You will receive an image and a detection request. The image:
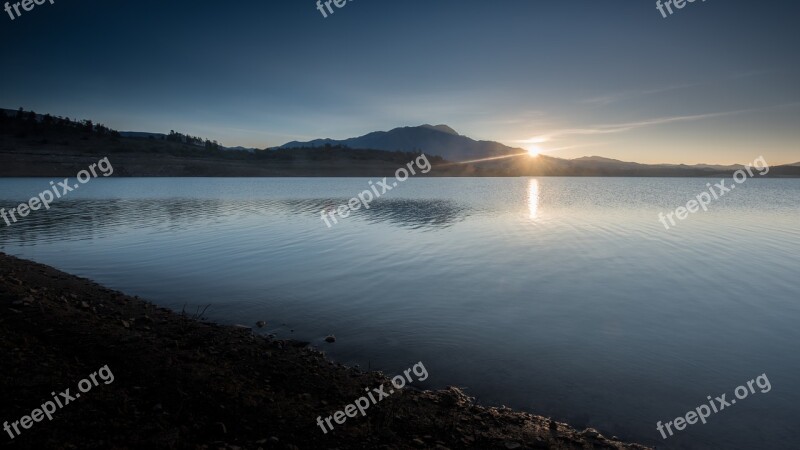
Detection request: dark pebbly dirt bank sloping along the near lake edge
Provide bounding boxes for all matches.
[0,252,648,450]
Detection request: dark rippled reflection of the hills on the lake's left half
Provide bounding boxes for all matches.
[0,198,468,245]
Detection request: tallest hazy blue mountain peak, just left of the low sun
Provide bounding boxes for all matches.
[278,124,527,162]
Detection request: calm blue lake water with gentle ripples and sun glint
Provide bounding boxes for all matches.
[0,178,800,449]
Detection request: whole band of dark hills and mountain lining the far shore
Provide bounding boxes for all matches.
[0,110,800,178]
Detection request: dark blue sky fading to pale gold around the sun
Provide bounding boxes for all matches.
[0,0,800,165]
